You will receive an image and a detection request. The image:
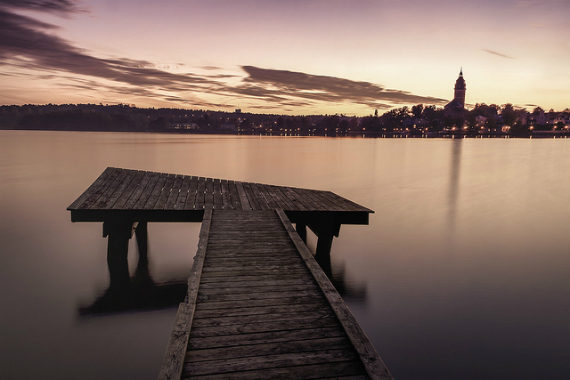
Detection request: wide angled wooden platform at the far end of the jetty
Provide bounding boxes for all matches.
[67,168,372,224]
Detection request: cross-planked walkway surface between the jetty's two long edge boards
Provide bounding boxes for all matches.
[175,211,374,378]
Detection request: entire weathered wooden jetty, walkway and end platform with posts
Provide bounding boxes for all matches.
[68,168,392,379]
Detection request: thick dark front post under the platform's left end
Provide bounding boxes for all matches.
[103,220,136,290]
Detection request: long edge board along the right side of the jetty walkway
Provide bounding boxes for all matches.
[276,210,392,379]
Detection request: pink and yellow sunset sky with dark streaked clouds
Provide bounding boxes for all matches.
[0,0,570,115]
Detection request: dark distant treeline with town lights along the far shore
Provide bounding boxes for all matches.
[0,104,570,136]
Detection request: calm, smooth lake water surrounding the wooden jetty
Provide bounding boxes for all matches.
[0,131,570,379]
